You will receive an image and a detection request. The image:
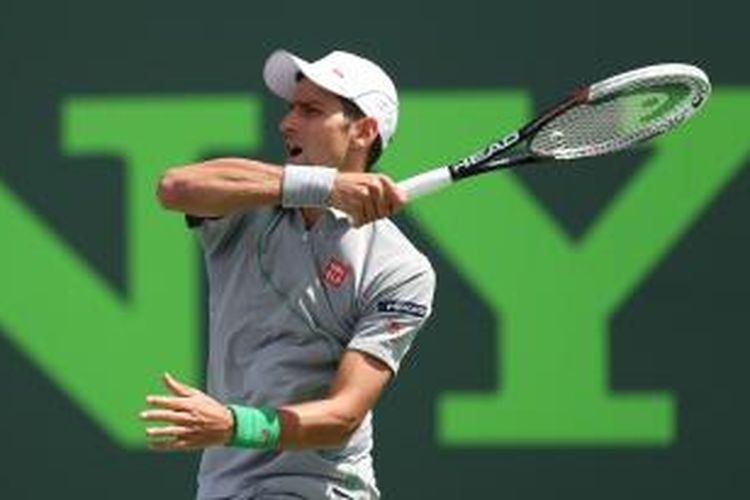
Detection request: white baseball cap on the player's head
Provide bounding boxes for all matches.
[263,50,398,148]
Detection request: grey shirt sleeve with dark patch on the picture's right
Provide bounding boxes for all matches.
[347,261,435,374]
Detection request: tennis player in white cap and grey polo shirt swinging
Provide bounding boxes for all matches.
[141,47,435,499]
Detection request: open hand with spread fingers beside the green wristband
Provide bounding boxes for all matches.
[140,373,234,451]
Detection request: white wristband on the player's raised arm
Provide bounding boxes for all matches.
[281,165,337,208]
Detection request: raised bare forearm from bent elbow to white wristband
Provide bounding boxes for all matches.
[157,158,283,217]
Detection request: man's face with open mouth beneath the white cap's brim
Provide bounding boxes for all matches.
[279,78,360,168]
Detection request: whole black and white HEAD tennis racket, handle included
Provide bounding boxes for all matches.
[398,63,711,199]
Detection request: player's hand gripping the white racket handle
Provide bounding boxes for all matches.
[329,172,407,227]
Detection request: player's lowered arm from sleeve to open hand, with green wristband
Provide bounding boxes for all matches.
[141,350,391,450]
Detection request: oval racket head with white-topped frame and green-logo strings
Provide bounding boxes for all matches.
[528,63,711,160]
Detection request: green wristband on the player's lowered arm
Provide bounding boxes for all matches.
[227,405,281,450]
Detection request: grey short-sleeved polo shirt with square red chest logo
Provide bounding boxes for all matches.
[191,207,435,499]
